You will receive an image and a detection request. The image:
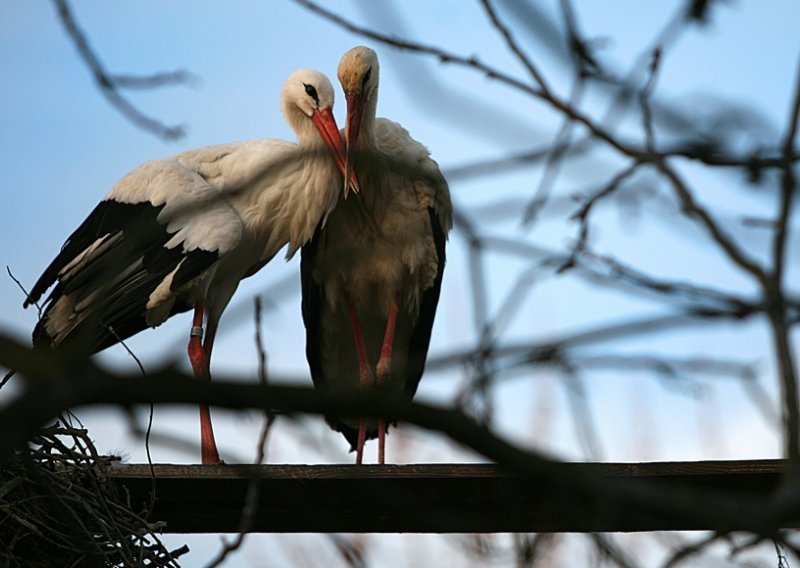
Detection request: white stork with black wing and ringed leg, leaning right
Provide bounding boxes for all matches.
[24,69,357,464]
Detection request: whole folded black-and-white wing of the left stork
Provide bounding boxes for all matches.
[26,156,242,353]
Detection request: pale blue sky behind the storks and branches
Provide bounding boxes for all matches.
[0,0,800,566]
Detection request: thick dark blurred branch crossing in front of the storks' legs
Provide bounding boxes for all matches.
[0,338,800,537]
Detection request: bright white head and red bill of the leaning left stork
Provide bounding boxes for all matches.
[281,69,358,191]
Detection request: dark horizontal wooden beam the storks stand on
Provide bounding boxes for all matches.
[110,460,784,533]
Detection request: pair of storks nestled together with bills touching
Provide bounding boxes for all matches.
[25,46,452,463]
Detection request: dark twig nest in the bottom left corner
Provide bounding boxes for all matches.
[0,420,188,568]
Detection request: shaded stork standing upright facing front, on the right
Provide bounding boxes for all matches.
[300,46,452,463]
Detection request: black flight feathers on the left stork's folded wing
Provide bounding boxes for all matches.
[26,200,219,352]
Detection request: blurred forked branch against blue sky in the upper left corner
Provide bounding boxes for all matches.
[53,0,193,140]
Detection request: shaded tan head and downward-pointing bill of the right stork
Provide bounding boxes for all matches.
[338,45,379,197]
